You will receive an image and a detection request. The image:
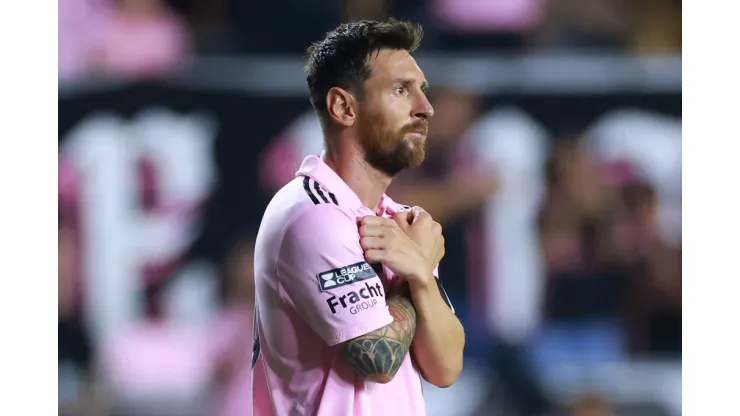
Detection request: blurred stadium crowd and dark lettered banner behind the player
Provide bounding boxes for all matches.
[59,0,682,416]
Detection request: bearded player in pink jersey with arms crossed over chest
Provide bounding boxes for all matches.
[253,20,465,416]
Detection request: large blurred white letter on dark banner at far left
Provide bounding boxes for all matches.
[60,109,216,339]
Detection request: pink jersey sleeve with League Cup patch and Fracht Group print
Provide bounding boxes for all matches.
[278,204,393,345]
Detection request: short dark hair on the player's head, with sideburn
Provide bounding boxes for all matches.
[305,19,424,128]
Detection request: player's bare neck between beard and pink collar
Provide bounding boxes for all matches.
[322,135,393,212]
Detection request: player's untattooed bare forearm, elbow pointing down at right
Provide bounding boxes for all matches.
[411,282,465,387]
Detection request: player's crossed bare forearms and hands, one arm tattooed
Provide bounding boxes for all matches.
[347,209,464,387]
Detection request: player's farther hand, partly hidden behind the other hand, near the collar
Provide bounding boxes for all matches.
[393,207,445,267]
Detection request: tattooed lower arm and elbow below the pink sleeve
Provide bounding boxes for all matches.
[340,295,416,378]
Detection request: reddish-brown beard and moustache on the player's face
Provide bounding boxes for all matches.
[358,109,428,177]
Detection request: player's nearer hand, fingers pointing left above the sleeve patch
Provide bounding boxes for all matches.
[359,215,436,284]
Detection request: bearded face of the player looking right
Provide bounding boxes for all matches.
[357,50,434,176]
